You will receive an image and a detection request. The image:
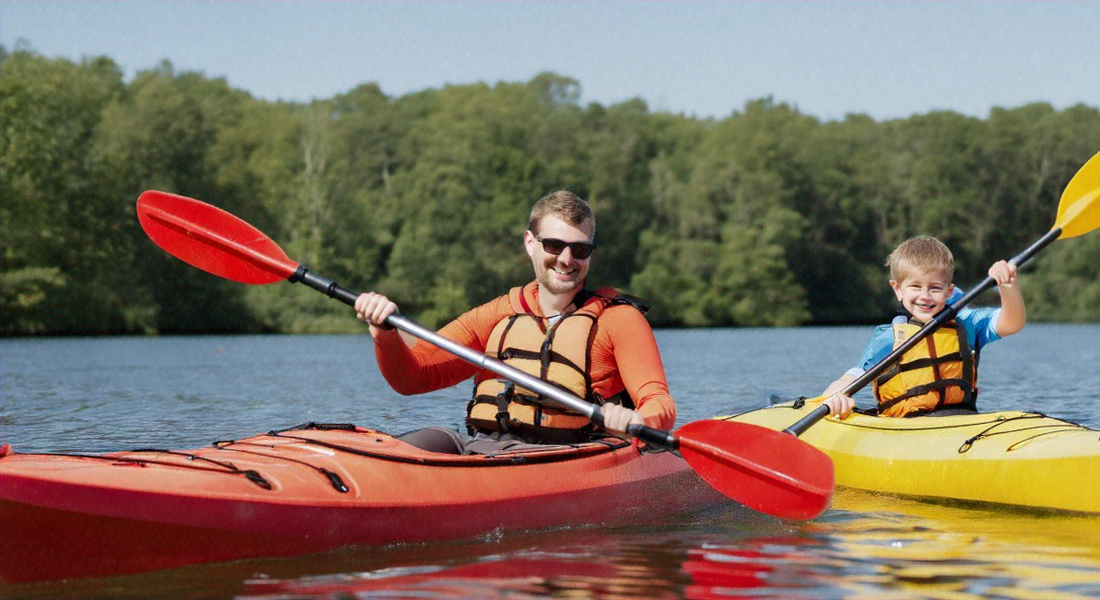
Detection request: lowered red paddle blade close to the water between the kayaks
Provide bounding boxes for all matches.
[675,419,834,520]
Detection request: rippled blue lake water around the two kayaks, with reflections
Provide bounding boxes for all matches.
[0,325,1100,599]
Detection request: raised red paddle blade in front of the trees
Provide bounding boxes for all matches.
[138,190,298,284]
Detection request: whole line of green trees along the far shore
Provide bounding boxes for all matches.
[0,48,1100,336]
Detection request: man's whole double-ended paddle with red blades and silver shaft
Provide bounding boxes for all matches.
[138,190,834,520]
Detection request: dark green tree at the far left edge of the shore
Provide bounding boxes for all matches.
[0,51,134,335]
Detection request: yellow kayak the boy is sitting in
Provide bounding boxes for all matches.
[716,401,1100,513]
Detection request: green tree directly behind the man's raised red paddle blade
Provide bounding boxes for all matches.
[95,63,256,332]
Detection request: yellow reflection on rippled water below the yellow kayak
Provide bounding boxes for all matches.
[812,491,1100,599]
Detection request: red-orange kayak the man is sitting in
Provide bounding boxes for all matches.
[0,424,724,582]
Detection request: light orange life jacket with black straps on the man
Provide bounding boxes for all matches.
[466,287,644,444]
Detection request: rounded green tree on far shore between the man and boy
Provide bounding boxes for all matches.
[631,100,815,326]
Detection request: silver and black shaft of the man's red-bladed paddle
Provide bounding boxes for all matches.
[288,265,679,450]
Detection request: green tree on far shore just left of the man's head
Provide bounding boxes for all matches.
[378,84,558,324]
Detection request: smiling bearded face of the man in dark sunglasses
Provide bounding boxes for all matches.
[524,215,593,294]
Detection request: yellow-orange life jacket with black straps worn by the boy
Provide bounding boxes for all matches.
[873,320,978,416]
